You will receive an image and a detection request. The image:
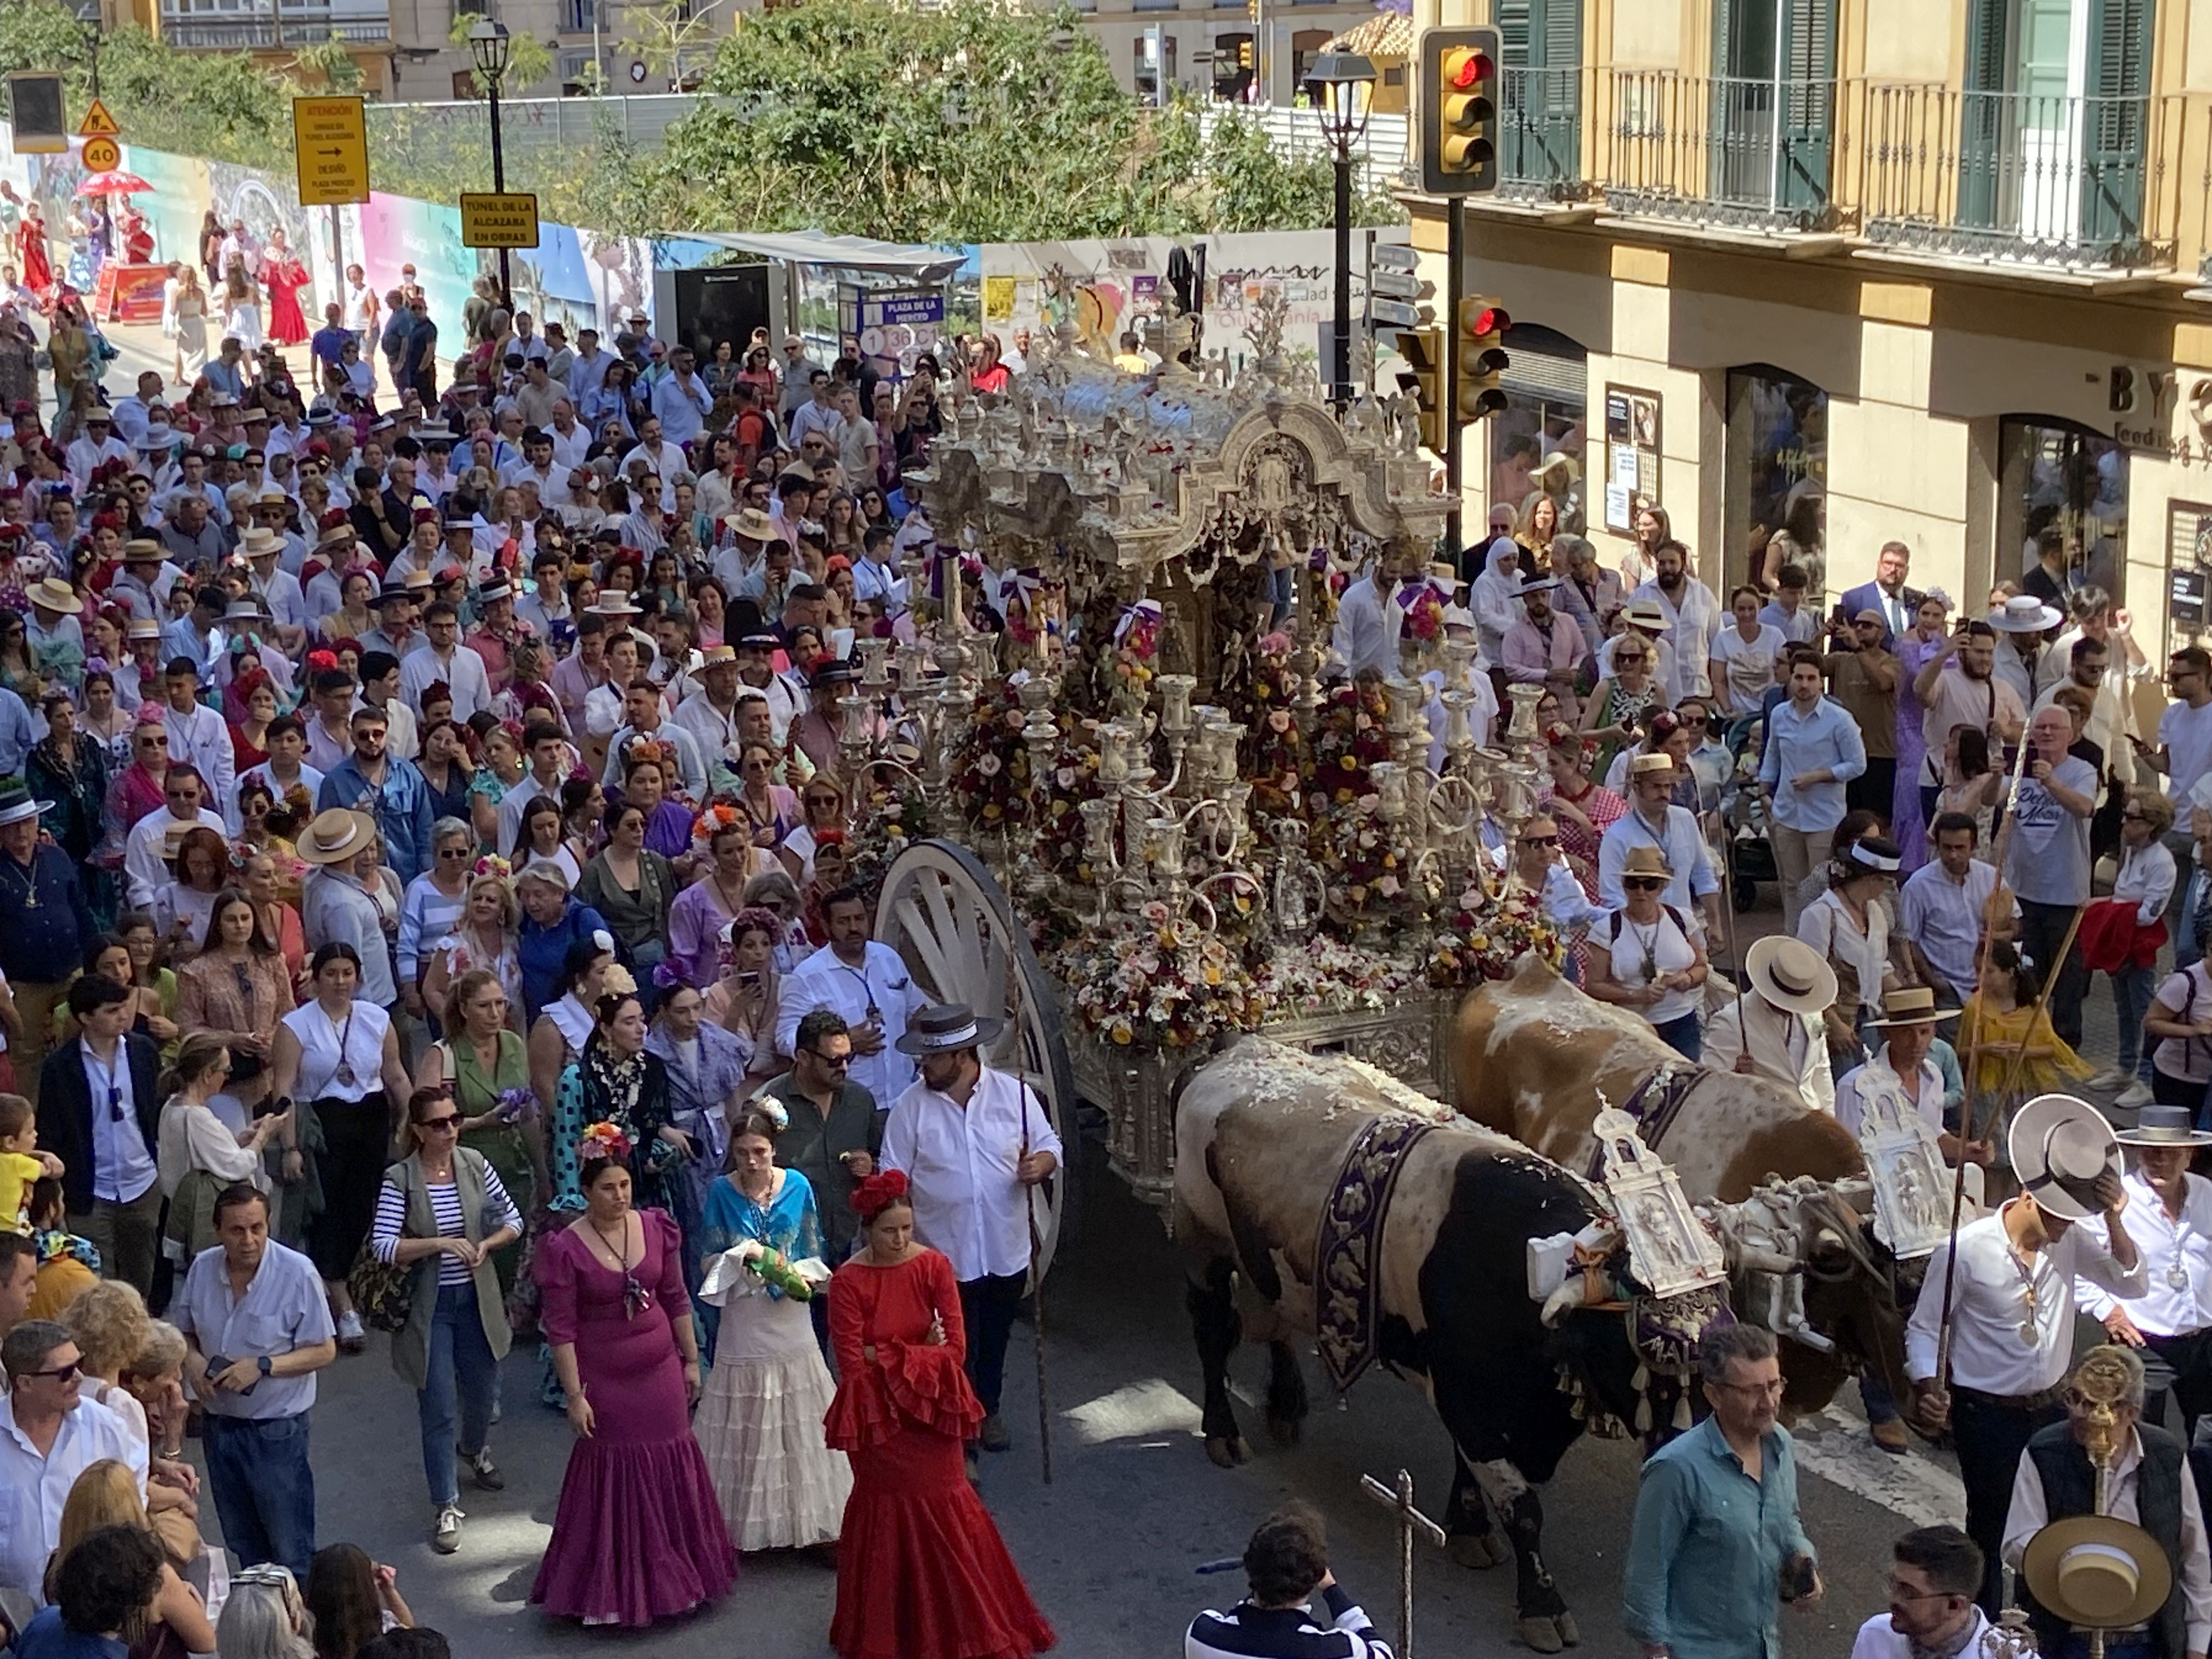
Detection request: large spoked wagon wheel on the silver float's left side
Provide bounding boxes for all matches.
[876,840,1082,1285]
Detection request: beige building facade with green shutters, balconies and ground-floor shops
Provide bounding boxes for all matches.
[1409,0,2212,652]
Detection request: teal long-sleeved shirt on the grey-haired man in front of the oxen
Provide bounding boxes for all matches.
[1621,1418,1814,1659]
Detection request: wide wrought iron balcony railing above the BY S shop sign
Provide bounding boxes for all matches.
[1849,84,2201,270]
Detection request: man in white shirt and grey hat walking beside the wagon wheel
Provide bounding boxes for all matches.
[878,1002,1062,1458]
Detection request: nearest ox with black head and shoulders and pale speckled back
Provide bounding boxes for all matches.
[1175,1037,1697,1652]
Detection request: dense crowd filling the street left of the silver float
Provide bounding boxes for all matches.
[0,253,1097,1659]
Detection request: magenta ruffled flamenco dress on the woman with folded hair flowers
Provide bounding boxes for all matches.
[531,1210,737,1626]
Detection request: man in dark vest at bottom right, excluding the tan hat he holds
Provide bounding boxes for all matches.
[2004,1345,2212,1659]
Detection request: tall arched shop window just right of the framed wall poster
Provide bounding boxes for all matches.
[1716,363,1822,606]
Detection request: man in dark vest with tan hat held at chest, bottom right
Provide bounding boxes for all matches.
[2004,1345,2212,1659]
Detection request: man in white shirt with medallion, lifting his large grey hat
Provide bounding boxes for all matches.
[1905,1095,2148,1612]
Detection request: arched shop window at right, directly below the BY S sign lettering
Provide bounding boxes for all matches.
[1973,416,2123,619]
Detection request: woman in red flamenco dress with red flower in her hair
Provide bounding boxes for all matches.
[823,1170,1053,1659]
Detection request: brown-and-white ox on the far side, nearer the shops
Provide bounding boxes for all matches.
[1451,958,1920,1413]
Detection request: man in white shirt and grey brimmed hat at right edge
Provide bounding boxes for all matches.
[2081,1106,2212,1442]
